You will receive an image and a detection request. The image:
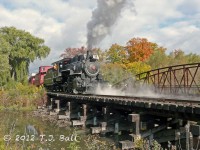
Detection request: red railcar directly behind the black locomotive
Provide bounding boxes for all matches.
[33,66,52,86]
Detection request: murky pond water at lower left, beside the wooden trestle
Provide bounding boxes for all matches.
[0,111,117,150]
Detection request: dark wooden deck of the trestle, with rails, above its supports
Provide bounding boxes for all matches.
[47,92,200,115]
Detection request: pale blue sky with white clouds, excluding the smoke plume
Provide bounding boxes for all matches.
[0,0,200,73]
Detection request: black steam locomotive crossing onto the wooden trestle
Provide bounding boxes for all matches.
[44,51,103,94]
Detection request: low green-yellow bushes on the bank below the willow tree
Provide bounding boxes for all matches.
[0,81,46,110]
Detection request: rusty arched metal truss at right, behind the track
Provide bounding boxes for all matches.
[136,63,200,95]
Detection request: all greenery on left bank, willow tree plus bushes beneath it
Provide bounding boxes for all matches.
[0,27,50,109]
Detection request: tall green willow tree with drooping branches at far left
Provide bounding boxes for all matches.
[0,27,50,81]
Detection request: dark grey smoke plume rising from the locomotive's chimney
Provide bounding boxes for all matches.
[87,0,134,49]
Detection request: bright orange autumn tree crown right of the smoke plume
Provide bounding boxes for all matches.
[126,38,153,62]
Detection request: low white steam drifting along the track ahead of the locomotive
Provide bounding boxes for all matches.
[94,80,199,100]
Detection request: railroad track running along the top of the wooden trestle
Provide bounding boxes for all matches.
[47,92,200,107]
